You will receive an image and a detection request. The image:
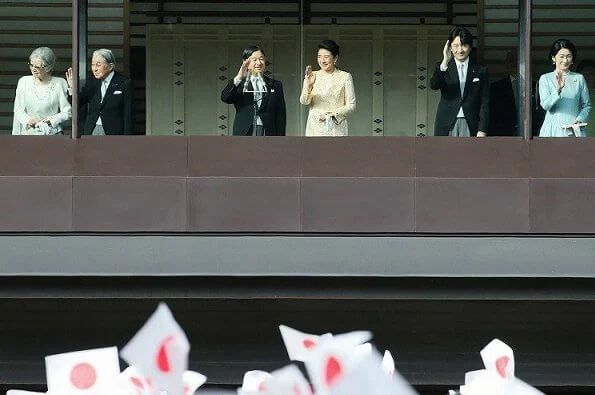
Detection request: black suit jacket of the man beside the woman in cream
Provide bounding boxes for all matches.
[221,75,287,136]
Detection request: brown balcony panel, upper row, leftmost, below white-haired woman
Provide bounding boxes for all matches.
[0,136,74,176]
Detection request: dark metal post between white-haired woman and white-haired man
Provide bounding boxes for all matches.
[71,0,88,139]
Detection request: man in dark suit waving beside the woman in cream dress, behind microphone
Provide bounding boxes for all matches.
[221,46,287,136]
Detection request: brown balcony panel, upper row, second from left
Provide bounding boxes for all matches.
[75,136,187,177]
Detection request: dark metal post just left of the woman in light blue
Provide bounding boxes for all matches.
[517,0,533,140]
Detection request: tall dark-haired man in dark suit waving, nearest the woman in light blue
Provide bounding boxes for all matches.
[430,27,490,137]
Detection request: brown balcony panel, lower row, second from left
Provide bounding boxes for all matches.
[73,177,186,232]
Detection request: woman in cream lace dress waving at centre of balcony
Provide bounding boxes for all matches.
[300,40,355,136]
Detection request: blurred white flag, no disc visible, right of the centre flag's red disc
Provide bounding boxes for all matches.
[326,351,417,395]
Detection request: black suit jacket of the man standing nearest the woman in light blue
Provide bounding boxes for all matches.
[430,59,490,136]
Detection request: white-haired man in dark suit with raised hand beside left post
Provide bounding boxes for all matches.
[66,48,134,136]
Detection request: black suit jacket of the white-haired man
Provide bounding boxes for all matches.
[79,72,134,135]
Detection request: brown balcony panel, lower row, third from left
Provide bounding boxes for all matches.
[188,177,300,232]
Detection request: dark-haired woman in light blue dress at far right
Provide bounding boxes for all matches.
[539,38,591,137]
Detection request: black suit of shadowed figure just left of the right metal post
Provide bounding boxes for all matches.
[489,77,518,136]
